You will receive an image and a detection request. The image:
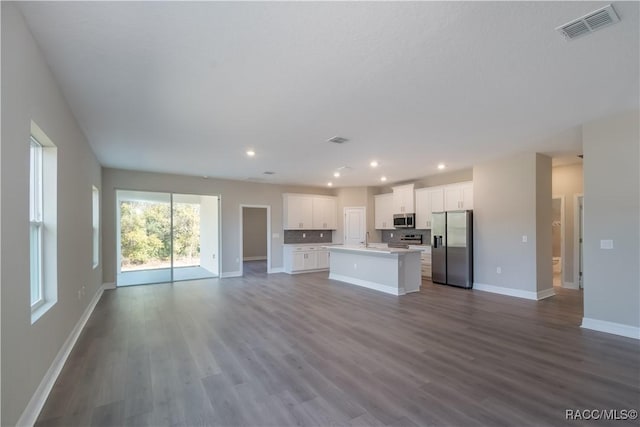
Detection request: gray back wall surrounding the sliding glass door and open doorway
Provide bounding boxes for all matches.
[102,168,333,283]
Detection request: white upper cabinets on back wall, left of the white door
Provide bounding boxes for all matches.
[283,193,338,230]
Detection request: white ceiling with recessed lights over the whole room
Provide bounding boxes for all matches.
[20,2,640,186]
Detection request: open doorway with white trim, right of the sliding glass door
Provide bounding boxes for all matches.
[239,205,271,276]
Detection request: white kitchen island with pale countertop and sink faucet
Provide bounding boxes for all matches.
[327,245,422,295]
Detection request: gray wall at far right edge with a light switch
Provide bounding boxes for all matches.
[583,110,640,327]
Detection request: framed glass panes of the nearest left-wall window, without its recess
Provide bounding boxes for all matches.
[29,136,44,310]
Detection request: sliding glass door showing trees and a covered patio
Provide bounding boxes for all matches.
[117,190,219,286]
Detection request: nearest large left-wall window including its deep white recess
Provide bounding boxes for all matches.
[29,122,58,324]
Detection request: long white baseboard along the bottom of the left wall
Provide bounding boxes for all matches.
[16,285,104,426]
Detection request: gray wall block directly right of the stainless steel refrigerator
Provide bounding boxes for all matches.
[473,153,552,292]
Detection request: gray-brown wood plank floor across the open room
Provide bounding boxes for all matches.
[37,270,640,426]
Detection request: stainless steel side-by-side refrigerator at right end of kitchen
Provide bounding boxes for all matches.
[431,211,473,288]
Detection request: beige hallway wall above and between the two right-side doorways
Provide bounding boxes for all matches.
[551,163,584,286]
